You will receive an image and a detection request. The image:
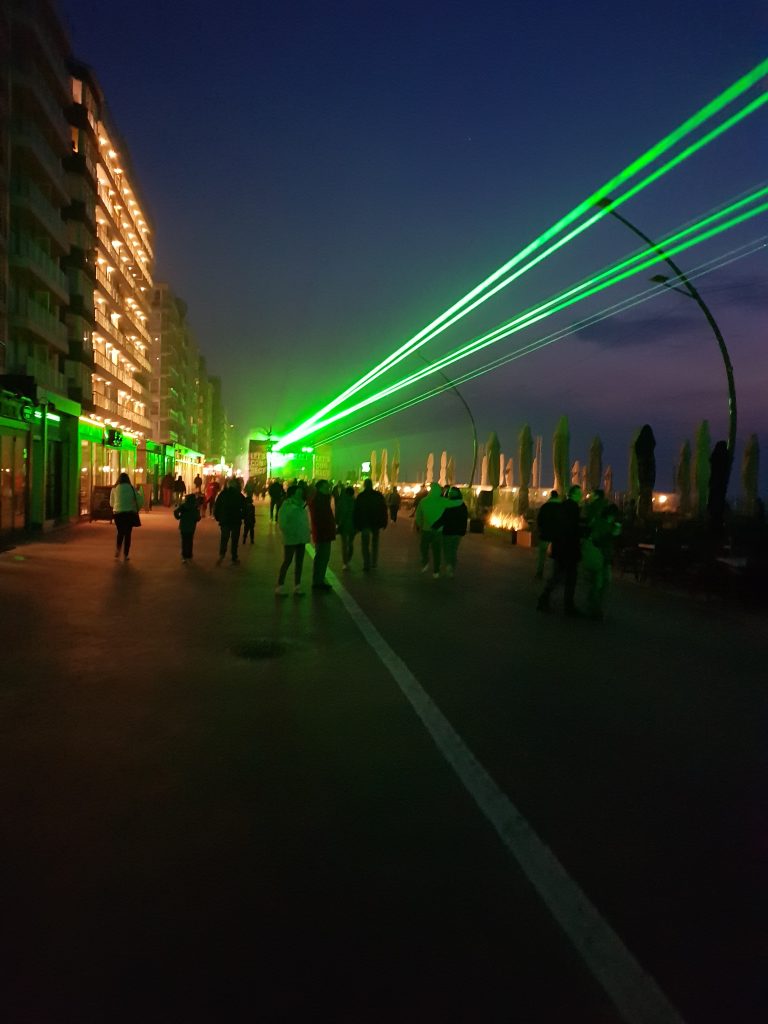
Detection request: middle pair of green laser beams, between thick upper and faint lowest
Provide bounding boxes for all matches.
[292,188,768,433]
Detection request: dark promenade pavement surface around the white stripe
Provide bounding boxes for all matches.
[0,506,768,1024]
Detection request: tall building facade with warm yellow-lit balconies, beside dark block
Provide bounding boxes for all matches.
[70,63,157,499]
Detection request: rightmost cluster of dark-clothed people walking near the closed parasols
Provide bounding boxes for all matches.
[536,484,622,621]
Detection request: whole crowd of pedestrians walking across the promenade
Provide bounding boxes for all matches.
[110,473,622,620]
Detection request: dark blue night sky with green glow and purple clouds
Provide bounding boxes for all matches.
[59,0,768,492]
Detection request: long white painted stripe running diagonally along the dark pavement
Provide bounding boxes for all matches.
[308,546,683,1024]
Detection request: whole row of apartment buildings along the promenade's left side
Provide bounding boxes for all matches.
[0,0,234,541]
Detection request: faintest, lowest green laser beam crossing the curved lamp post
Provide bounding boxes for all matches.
[316,236,768,445]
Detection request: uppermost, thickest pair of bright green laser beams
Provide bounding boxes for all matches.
[275,60,768,449]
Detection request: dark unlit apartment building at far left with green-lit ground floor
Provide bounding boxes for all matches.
[0,0,81,532]
